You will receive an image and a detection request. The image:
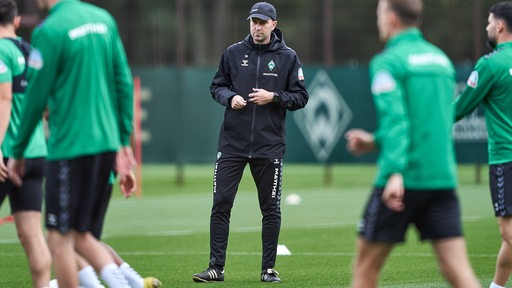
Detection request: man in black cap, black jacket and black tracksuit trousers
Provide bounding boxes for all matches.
[192,2,308,282]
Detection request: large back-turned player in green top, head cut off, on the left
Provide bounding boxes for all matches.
[8,0,135,287]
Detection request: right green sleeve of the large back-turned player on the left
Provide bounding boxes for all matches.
[113,24,133,146]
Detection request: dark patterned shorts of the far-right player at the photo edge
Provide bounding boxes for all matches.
[489,162,512,217]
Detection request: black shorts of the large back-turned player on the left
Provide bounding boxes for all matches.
[46,152,116,233]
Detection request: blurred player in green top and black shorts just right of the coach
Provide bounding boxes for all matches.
[346,0,480,288]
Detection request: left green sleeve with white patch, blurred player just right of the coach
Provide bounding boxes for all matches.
[372,66,410,179]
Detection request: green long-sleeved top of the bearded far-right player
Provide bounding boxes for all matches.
[455,42,512,164]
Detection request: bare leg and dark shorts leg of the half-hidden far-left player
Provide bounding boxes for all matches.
[8,158,51,287]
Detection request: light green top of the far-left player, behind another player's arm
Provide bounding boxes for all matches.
[0,38,46,158]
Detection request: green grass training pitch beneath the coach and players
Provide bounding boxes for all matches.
[0,163,500,288]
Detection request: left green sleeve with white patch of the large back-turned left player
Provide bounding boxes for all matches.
[13,29,56,159]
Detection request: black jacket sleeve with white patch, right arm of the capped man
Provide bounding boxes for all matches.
[276,53,309,111]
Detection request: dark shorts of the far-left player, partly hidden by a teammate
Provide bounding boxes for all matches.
[0,158,45,213]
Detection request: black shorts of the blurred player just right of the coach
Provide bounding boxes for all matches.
[358,188,462,243]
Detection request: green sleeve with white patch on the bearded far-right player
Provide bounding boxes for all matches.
[454,58,494,121]
